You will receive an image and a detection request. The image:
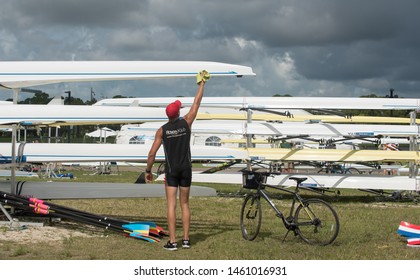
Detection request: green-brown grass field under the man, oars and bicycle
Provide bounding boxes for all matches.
[0,170,420,260]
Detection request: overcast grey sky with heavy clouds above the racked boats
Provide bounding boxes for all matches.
[0,0,420,100]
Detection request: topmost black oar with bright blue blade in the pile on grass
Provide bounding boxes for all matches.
[0,191,159,236]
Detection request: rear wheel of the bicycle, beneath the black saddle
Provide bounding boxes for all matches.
[295,198,340,246]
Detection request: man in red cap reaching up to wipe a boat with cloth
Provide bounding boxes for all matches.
[146,70,210,251]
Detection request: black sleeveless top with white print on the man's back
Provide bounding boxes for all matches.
[162,119,191,174]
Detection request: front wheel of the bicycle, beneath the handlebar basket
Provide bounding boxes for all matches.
[241,193,262,241]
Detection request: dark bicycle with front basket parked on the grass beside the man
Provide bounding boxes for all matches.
[240,170,340,246]
